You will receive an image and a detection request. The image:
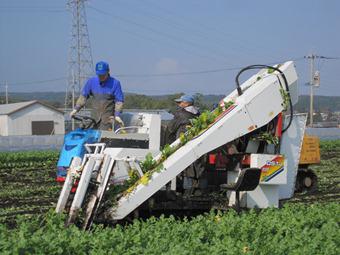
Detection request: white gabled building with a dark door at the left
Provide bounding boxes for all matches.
[0,101,65,136]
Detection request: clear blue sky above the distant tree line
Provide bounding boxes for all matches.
[0,0,340,96]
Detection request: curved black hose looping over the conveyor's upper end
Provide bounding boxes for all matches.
[235,65,293,133]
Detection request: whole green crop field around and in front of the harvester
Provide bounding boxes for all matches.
[0,141,340,254]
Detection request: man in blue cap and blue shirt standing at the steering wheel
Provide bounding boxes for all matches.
[70,61,124,130]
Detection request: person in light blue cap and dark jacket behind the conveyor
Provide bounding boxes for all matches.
[167,95,199,144]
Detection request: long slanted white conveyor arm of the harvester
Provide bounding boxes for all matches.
[112,62,297,219]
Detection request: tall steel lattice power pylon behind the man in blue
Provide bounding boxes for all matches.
[65,0,93,129]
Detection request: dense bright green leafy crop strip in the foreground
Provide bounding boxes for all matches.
[0,203,340,255]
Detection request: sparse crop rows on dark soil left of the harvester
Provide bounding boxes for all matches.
[0,156,61,224]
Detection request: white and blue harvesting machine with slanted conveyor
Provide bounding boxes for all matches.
[56,61,306,229]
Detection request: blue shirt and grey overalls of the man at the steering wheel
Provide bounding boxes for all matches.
[77,76,124,128]
